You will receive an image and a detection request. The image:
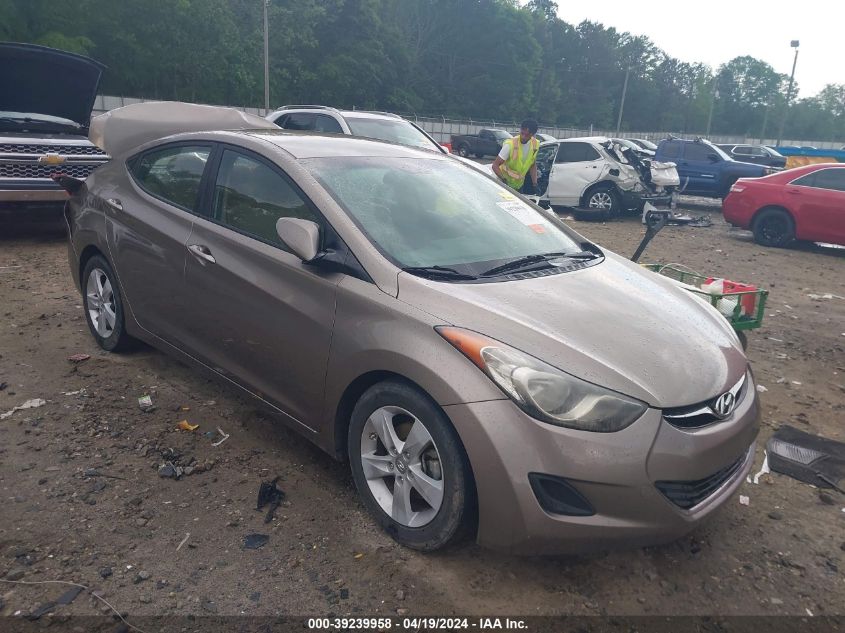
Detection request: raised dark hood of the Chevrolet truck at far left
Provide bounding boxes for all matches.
[0,43,105,127]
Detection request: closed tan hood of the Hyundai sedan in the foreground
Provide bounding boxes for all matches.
[398,253,748,408]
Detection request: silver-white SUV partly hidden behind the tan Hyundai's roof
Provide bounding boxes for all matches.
[266,105,449,154]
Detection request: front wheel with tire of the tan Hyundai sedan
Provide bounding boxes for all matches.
[348,380,475,551]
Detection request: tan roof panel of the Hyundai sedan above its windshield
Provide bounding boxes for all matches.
[241,129,448,160]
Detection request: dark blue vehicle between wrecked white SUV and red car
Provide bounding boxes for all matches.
[654,138,777,198]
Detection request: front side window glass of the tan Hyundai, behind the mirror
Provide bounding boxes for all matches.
[214,150,319,251]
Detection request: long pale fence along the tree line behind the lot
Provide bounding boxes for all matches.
[94,95,842,149]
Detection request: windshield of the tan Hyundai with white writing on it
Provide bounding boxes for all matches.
[303,157,583,275]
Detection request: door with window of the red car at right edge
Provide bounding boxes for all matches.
[786,167,845,244]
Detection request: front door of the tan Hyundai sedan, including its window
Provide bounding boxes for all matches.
[185,146,343,429]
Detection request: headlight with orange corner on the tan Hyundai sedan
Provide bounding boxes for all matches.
[436,327,648,433]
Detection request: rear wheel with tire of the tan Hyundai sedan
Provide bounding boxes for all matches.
[80,255,134,352]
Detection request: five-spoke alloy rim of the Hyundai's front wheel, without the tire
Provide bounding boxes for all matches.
[361,406,443,528]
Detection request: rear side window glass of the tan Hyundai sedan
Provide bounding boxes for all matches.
[129,145,211,211]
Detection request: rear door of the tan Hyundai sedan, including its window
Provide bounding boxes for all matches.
[106,143,212,347]
